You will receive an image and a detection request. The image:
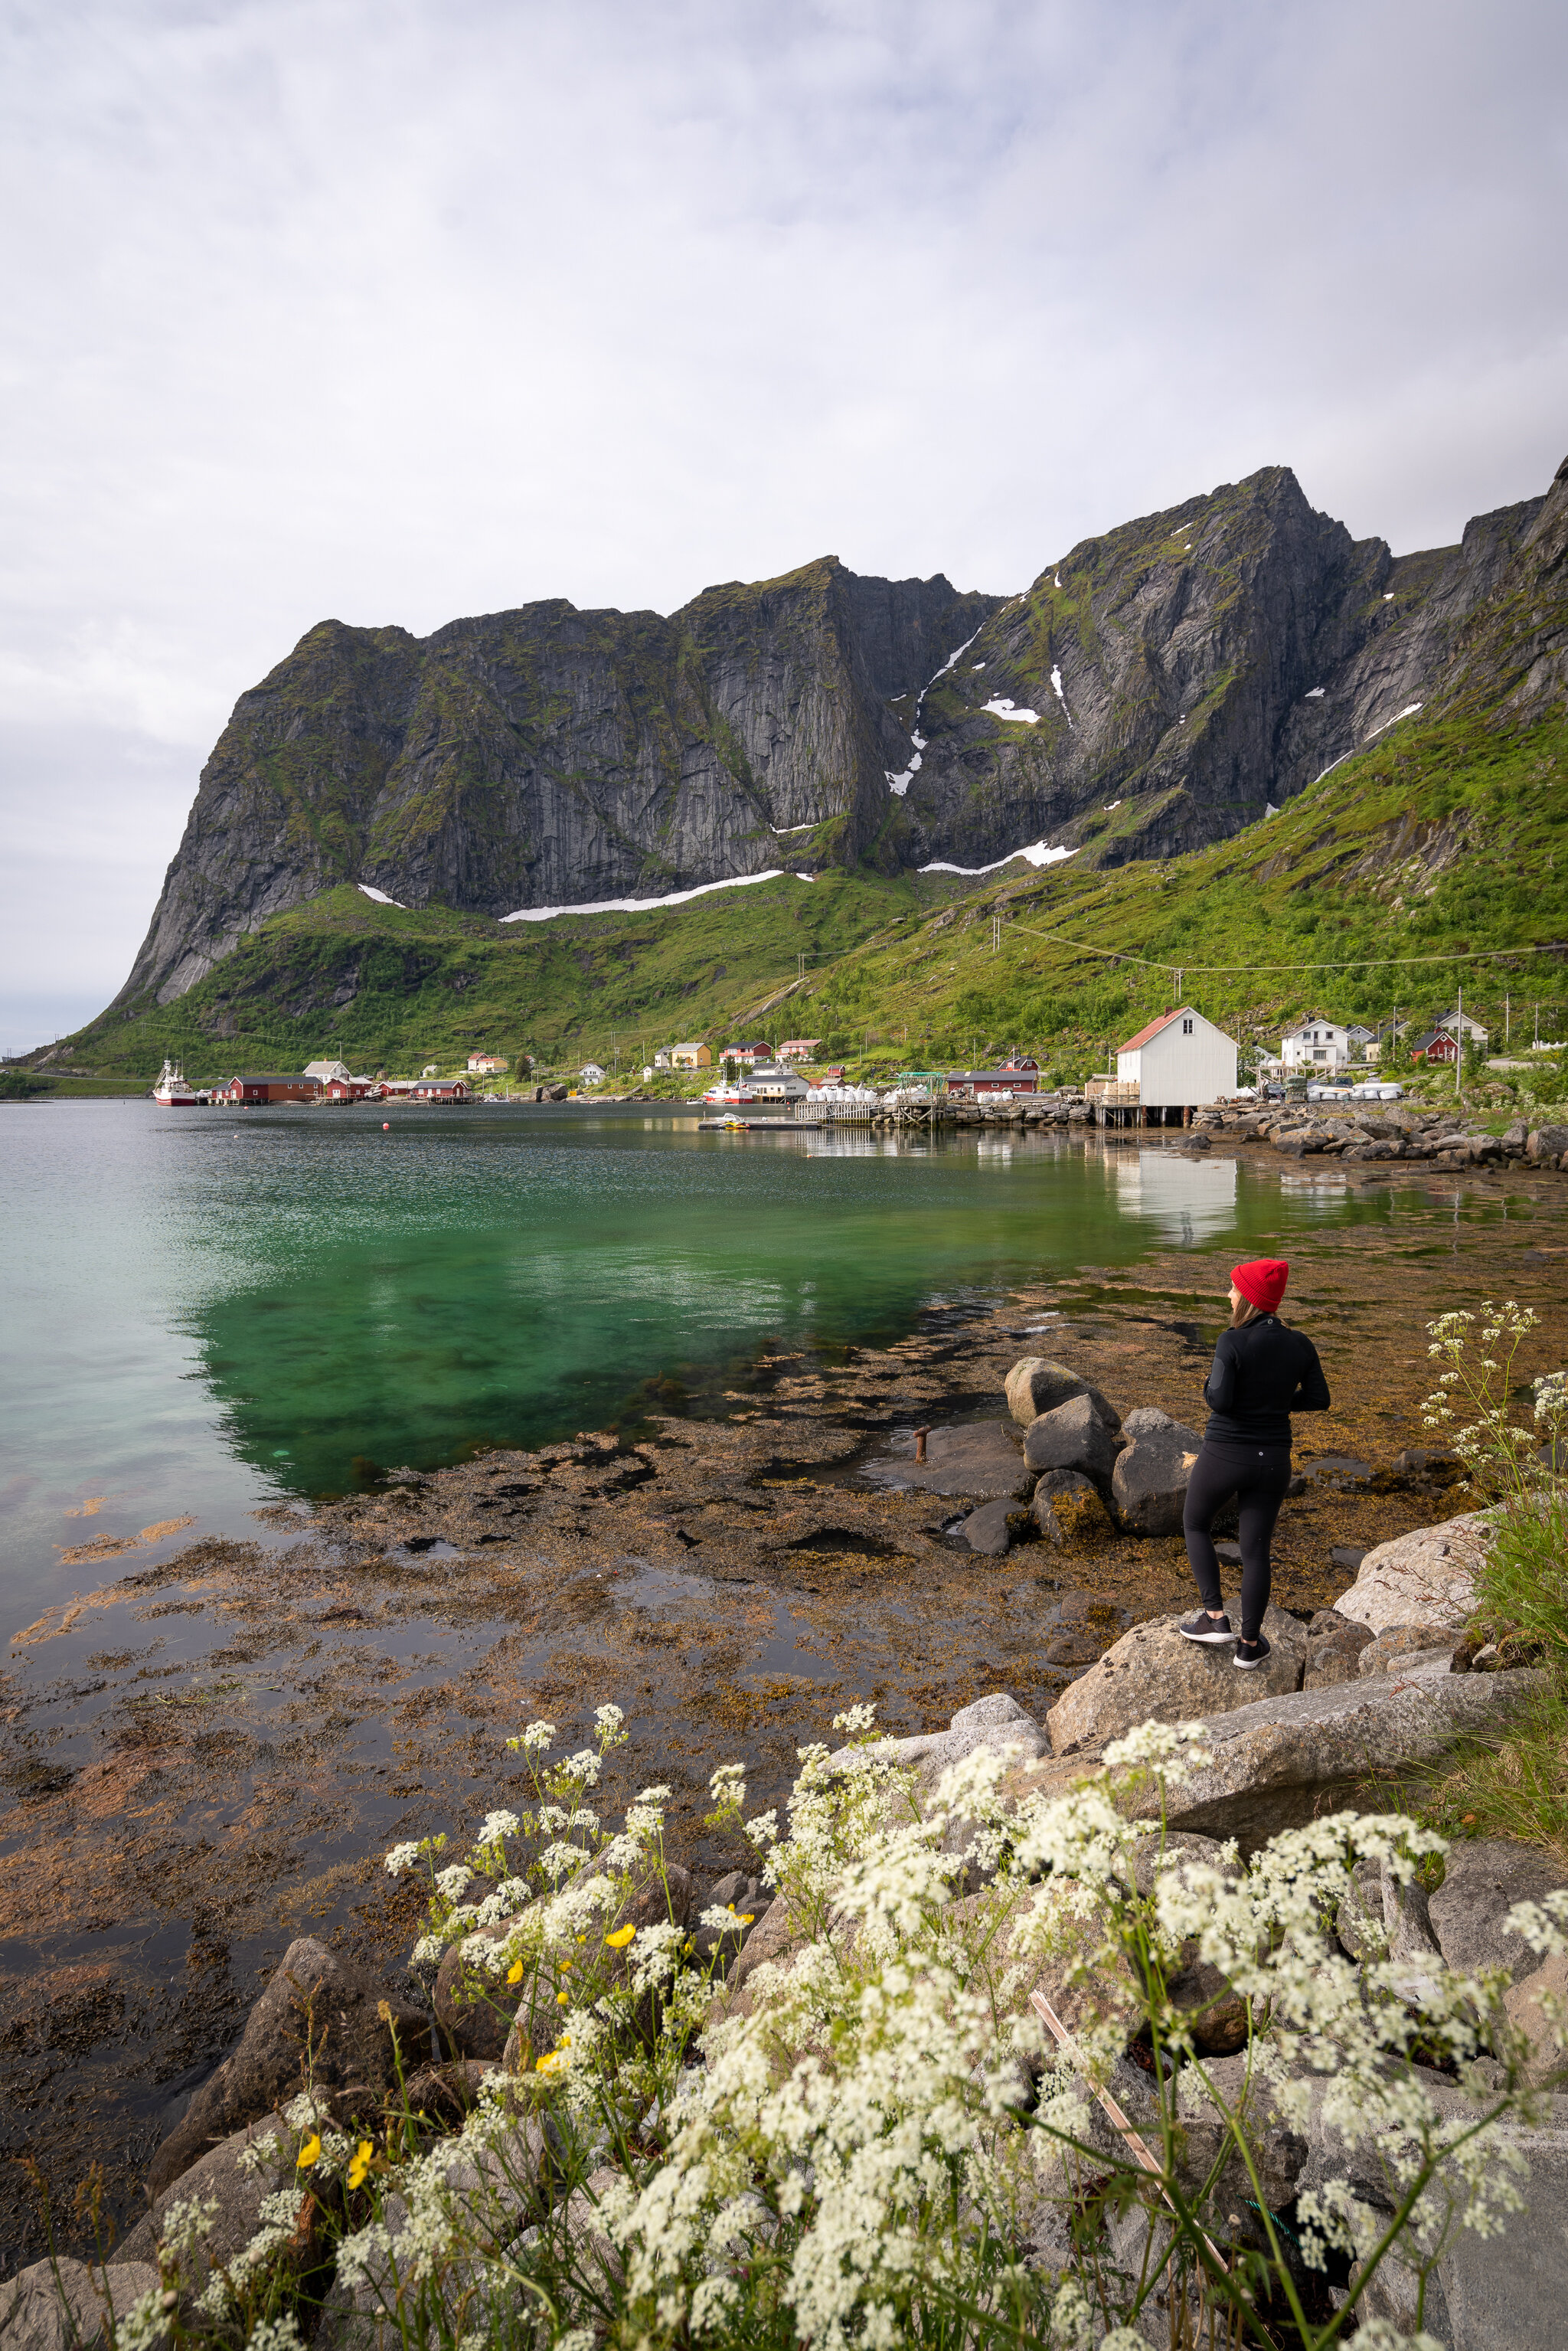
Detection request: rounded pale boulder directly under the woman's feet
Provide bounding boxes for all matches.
[1046,1604,1307,1758]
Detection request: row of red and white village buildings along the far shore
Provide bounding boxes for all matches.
[153,1004,1488,1121]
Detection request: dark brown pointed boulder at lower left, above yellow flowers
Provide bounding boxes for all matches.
[148,1935,430,2189]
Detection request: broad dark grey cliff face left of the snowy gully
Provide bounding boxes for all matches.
[118,574,997,1004]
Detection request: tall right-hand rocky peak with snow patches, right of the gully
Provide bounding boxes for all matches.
[898,468,1542,868]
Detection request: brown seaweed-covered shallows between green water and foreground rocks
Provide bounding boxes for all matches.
[0,1147,1568,2269]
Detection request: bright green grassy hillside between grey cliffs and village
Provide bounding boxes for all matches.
[31,695,1568,1079]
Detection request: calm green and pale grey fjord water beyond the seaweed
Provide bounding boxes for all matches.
[12,1103,1387,1622]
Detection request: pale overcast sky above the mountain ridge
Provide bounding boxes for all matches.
[0,0,1568,1051]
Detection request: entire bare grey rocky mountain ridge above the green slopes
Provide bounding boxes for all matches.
[115,466,1568,1006]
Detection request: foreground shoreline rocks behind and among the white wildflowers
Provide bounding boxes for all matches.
[2,1495,1568,2351]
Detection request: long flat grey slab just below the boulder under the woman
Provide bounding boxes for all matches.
[1123,1655,1547,1852]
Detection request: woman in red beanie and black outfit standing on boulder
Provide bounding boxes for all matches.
[1182,1257,1328,1672]
